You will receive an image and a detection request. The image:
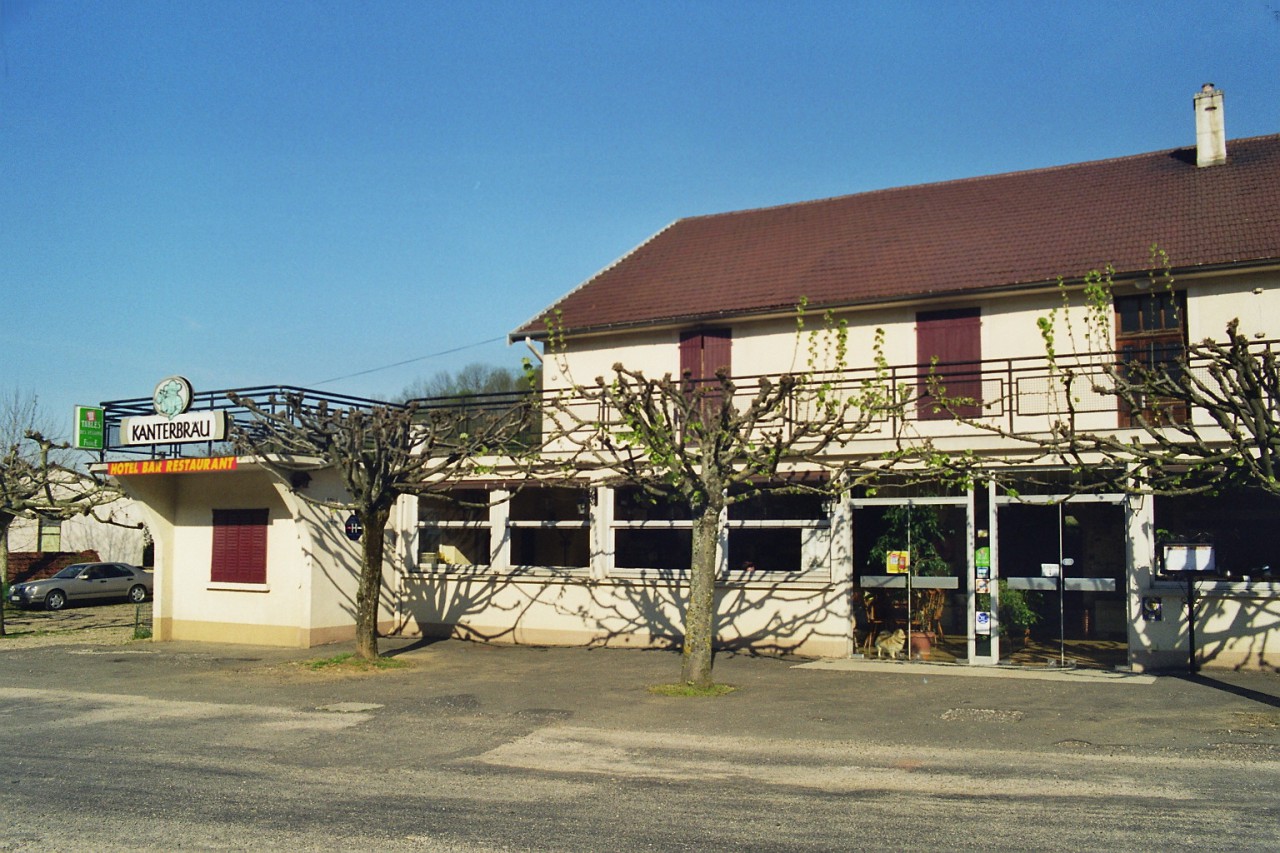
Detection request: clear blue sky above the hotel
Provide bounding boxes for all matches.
[0,0,1280,438]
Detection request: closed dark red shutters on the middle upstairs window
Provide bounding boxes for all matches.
[915,309,982,420]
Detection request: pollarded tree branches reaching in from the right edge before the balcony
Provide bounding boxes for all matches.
[1003,246,1280,494]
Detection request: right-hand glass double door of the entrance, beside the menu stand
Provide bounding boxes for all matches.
[997,496,1128,669]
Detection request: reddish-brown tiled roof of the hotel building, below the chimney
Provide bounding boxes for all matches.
[512,136,1280,337]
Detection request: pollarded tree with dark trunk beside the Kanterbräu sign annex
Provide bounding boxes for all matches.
[229,393,534,660]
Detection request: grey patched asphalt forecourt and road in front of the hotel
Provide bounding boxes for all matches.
[0,627,1280,850]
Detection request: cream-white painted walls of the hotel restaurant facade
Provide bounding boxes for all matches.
[99,262,1280,670]
